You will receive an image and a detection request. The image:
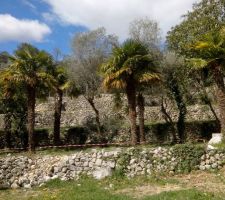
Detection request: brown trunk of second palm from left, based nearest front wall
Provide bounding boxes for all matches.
[27,86,36,153]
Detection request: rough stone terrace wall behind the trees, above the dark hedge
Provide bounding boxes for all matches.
[0,94,217,128]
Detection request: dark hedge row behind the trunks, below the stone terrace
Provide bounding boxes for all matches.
[0,120,218,148]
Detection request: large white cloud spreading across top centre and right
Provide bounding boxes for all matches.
[44,0,199,39]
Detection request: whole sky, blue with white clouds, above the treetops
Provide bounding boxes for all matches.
[0,0,195,54]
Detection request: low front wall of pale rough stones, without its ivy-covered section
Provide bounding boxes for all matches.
[0,147,225,188]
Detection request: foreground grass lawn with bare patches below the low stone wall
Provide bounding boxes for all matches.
[0,173,223,200]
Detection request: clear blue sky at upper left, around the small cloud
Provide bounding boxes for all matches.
[0,0,87,54]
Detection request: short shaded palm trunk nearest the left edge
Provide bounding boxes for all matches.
[4,113,12,148]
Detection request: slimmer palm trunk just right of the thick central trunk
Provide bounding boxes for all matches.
[137,93,146,144]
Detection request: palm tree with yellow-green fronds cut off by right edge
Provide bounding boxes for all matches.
[191,28,225,137]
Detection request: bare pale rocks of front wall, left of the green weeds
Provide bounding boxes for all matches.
[0,150,119,188]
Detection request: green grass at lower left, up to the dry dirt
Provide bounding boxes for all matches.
[0,178,131,200]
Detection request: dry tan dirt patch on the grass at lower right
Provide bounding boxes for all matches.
[116,167,225,198]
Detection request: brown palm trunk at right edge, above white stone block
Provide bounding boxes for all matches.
[213,65,225,137]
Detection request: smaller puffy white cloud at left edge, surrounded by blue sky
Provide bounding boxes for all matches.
[0,14,51,42]
